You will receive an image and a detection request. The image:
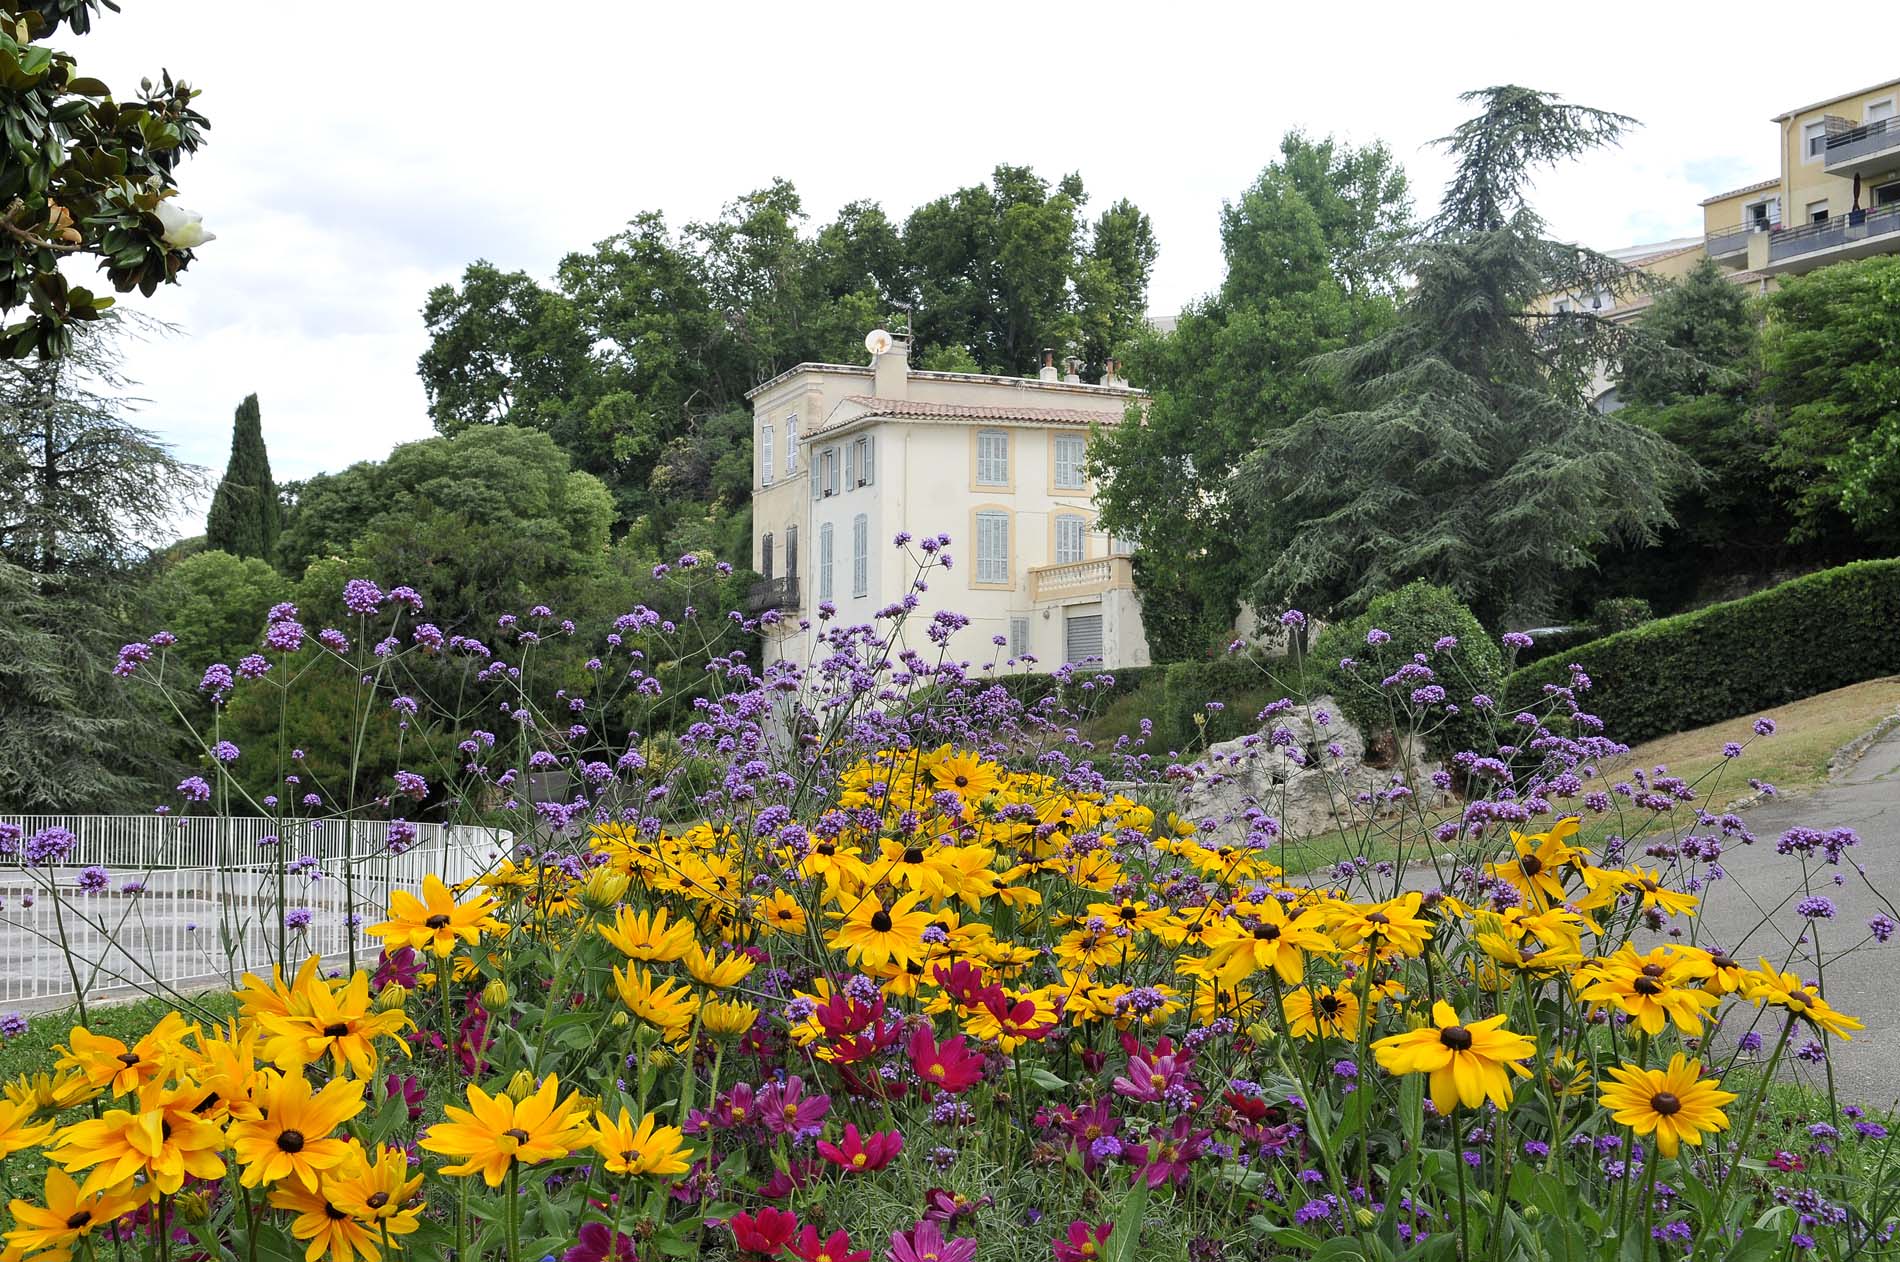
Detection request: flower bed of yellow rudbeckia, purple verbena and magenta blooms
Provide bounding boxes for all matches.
[0,545,1894,1262]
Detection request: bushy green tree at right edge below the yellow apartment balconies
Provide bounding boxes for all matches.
[1761,255,1900,549]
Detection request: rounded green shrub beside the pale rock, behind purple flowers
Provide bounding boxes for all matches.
[1313,580,1505,755]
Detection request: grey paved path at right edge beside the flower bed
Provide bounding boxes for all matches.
[1697,730,1900,1108]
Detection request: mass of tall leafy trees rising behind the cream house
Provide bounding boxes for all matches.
[418,165,1155,549]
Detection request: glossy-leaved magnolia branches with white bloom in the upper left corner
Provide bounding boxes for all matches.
[0,0,209,359]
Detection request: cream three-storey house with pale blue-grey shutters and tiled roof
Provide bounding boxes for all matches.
[749,331,1148,671]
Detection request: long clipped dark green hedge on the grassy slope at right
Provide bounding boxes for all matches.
[1505,559,1900,745]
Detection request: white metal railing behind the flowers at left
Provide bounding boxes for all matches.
[0,815,513,1007]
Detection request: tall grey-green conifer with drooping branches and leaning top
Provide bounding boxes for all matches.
[1243,87,1693,625]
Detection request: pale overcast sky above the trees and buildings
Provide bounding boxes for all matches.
[61,0,1900,528]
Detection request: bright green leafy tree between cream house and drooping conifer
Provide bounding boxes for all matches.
[1093,133,1410,660]
